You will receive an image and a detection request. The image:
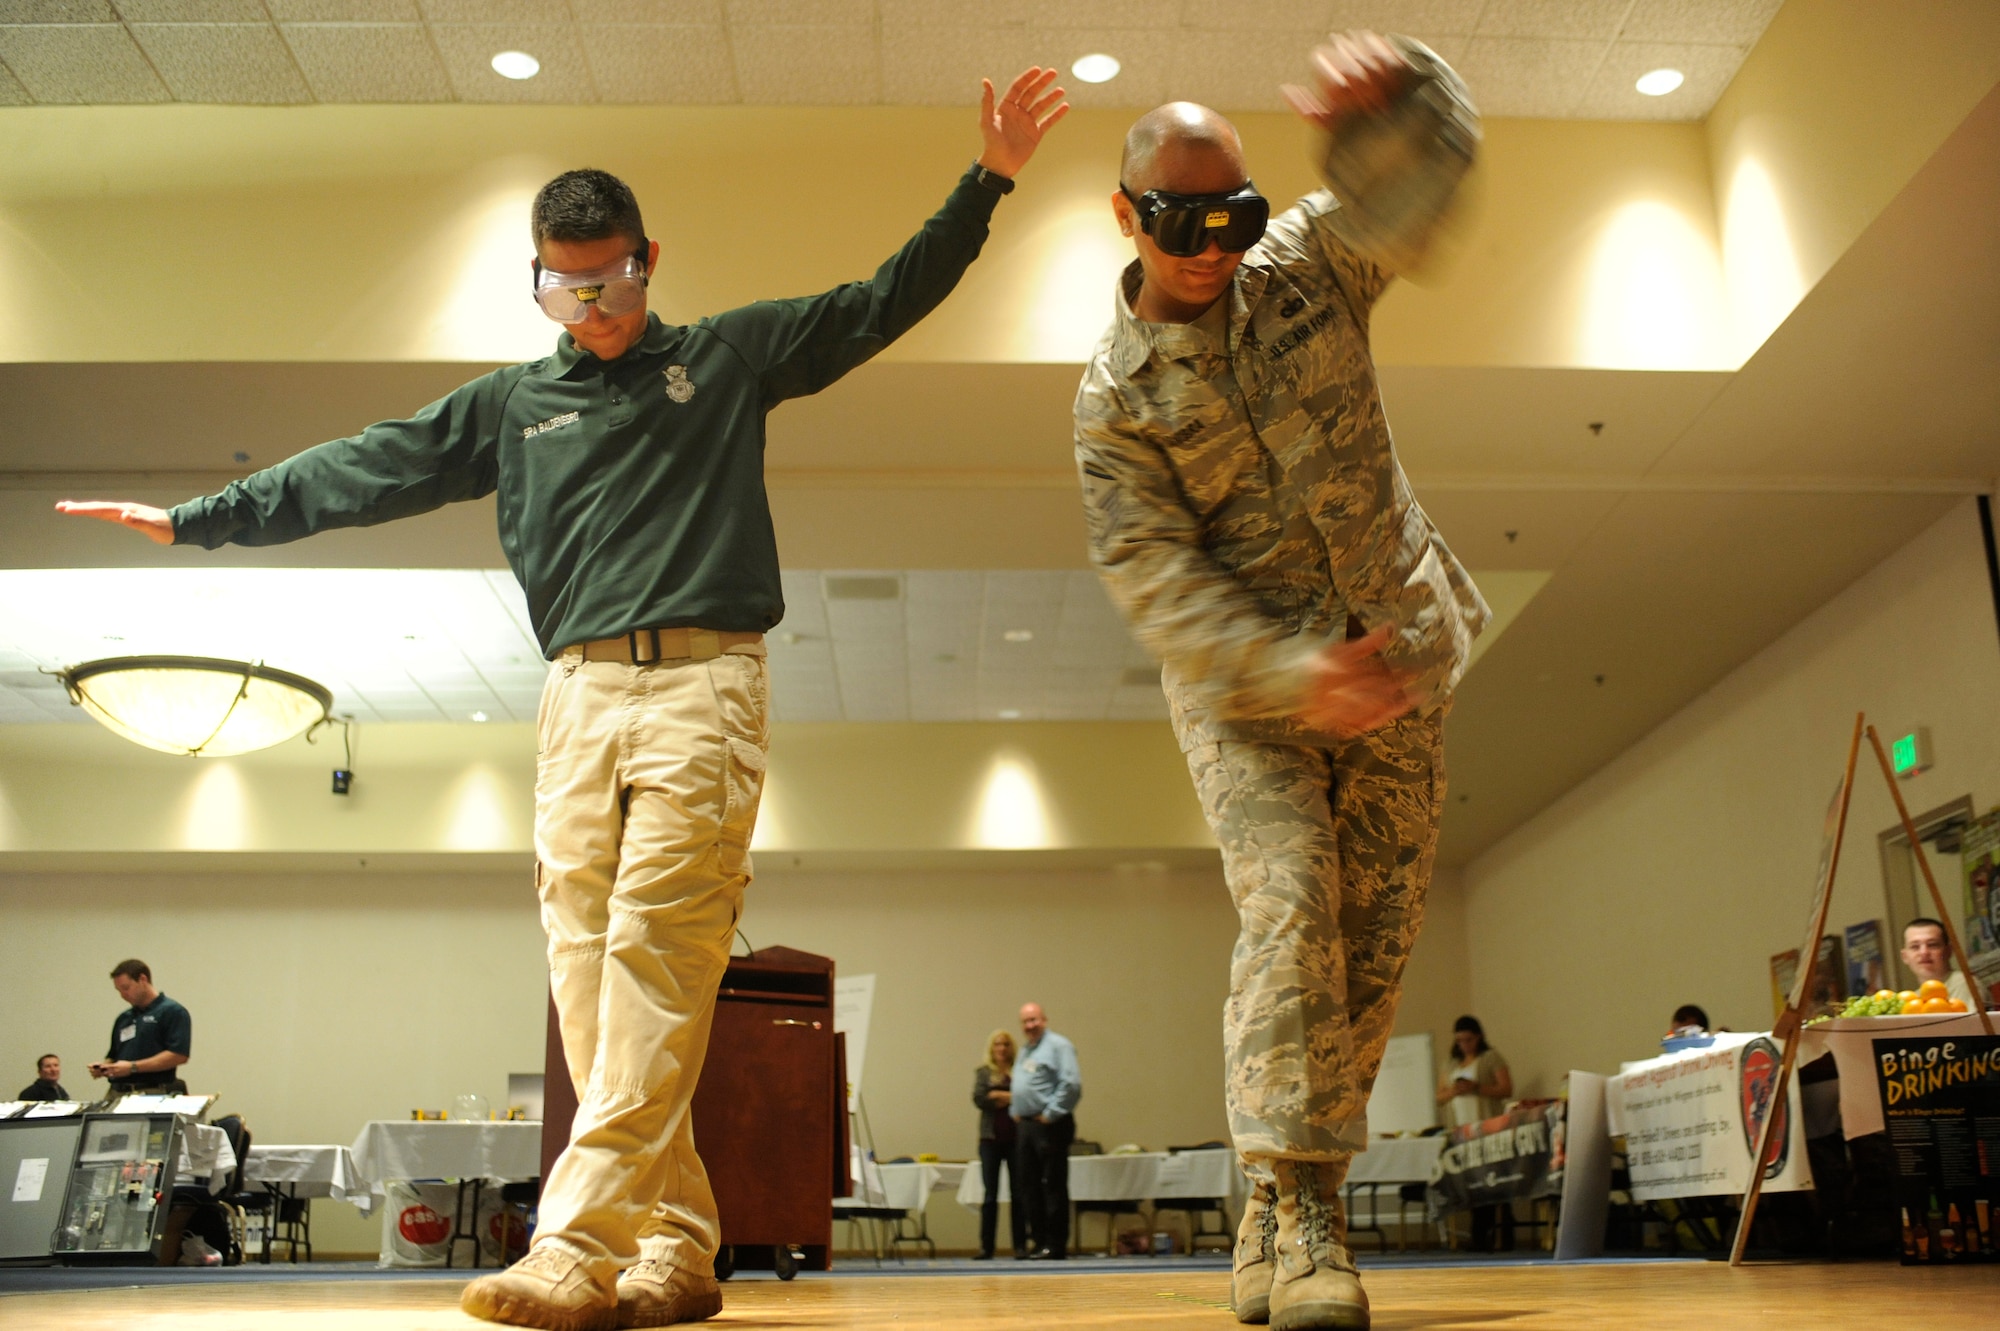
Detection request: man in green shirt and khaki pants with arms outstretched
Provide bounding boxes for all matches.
[58,68,1068,1331]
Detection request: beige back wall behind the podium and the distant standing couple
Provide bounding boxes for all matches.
[0,857,1464,1251]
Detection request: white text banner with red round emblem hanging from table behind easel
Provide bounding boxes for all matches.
[1604,1035,1812,1201]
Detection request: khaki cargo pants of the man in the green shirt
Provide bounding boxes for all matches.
[534,644,770,1283]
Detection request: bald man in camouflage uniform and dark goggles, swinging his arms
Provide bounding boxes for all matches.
[1076,34,1488,1329]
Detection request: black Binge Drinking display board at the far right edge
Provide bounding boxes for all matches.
[1874,1035,2000,1267]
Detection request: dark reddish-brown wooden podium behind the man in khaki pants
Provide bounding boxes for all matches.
[542,947,848,1279]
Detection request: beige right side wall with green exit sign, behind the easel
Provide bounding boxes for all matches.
[1464,491,2000,1093]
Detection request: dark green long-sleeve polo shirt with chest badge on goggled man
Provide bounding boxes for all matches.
[170,170,1000,658]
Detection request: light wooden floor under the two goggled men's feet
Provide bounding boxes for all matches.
[0,1261,1976,1331]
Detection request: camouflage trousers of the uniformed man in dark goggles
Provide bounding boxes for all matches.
[1188,707,1448,1183]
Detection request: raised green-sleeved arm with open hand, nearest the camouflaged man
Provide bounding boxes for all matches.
[708,66,1070,406]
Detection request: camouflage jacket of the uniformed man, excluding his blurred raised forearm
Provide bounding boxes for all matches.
[1076,171,1490,747]
